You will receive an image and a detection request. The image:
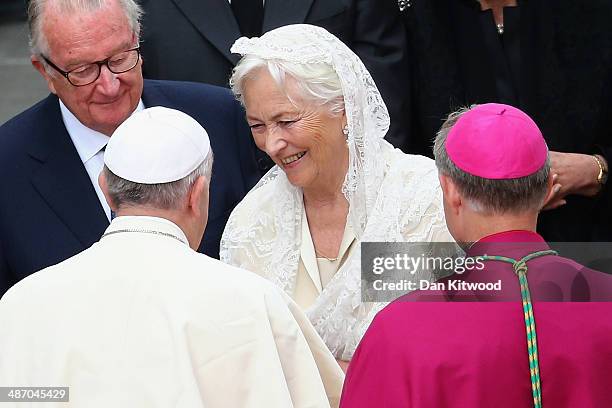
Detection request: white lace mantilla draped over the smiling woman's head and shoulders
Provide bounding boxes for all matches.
[220,24,451,360]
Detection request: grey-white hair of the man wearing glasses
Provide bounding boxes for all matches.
[28,0,142,56]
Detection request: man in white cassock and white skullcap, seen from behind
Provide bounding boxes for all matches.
[0,107,343,408]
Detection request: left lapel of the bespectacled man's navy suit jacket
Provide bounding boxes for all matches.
[30,95,108,247]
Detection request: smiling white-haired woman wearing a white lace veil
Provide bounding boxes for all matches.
[221,24,452,361]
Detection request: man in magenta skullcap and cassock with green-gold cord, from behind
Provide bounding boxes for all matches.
[341,104,612,408]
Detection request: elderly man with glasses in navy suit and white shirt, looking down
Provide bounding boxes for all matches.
[0,0,261,295]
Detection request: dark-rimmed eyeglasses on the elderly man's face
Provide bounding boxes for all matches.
[41,47,140,86]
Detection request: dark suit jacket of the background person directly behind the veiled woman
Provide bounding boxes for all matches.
[141,0,410,148]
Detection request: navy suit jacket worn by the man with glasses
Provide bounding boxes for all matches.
[0,81,261,295]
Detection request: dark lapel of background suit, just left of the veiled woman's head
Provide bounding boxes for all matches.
[173,0,240,64]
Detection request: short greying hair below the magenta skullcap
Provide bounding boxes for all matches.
[434,105,550,214]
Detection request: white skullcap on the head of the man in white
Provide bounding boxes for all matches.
[104,106,210,184]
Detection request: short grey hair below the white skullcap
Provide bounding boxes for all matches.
[103,151,213,210]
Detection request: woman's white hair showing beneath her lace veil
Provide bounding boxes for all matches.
[230,55,344,114]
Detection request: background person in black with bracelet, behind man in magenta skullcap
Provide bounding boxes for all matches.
[400,0,612,241]
